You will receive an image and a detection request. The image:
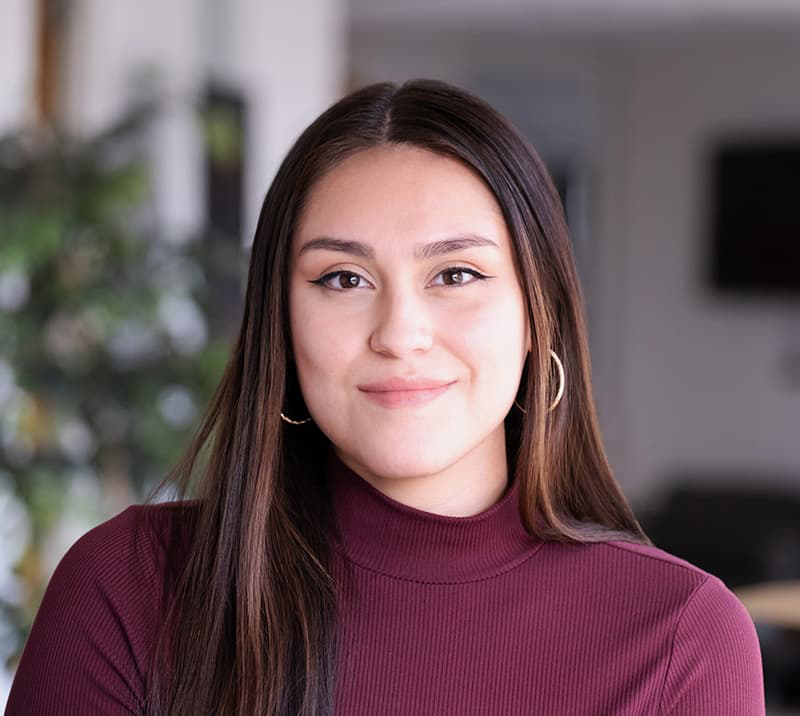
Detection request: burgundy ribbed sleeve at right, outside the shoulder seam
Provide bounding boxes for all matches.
[658,576,765,716]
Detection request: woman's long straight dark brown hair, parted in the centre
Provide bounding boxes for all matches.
[142,80,649,716]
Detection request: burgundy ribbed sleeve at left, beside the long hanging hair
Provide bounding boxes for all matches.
[5,507,157,716]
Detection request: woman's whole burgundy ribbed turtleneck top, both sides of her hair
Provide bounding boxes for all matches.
[6,450,764,716]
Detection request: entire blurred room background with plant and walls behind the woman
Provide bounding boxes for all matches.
[0,0,800,714]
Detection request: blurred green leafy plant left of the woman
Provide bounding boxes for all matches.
[0,99,245,666]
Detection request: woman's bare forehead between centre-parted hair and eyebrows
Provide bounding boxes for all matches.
[294,145,510,251]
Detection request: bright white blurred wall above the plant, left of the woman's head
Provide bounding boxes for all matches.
[65,0,346,242]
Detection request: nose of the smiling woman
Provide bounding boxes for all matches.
[369,291,433,357]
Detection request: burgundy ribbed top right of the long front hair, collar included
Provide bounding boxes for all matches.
[329,450,764,716]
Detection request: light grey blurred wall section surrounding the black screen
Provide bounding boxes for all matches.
[617,35,800,504]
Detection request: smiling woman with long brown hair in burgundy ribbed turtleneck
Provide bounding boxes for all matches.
[9,80,764,716]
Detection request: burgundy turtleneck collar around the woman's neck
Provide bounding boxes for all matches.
[327,450,542,584]
